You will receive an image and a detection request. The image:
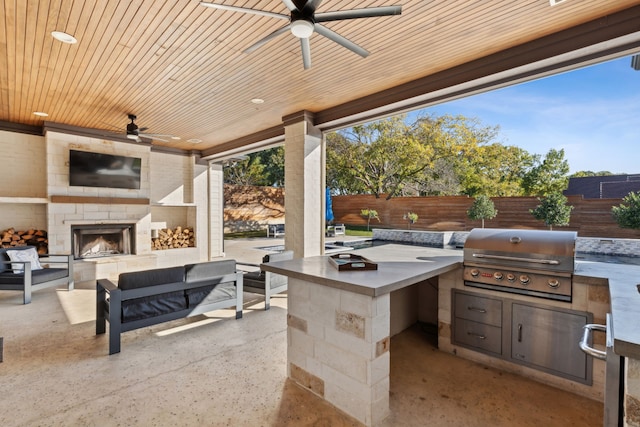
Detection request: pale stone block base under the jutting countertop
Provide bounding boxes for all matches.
[287,278,391,426]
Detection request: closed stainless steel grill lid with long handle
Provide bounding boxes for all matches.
[463,228,578,273]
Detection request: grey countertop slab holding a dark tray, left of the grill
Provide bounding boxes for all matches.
[261,244,462,297]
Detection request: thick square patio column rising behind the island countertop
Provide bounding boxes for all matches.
[283,111,325,258]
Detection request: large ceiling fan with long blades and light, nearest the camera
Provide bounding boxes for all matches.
[200,0,402,70]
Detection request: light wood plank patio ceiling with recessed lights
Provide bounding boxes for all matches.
[0,0,640,155]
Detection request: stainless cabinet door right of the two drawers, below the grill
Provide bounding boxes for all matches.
[511,303,587,382]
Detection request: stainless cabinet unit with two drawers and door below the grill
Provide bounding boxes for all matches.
[452,289,593,384]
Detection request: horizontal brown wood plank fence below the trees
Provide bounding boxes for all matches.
[224,185,640,239]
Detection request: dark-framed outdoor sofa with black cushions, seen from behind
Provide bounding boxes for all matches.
[96,260,243,354]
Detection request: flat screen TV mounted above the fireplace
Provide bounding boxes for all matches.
[69,150,142,190]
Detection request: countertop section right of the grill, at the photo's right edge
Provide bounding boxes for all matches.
[574,261,640,360]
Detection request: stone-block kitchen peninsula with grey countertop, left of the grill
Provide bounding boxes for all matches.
[262,245,462,426]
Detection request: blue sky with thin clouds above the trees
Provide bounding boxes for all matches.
[419,57,640,174]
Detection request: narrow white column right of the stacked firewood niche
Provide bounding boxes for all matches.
[209,163,224,259]
